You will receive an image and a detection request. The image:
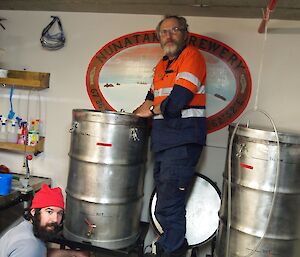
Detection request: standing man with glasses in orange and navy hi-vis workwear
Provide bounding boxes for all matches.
[134,16,206,257]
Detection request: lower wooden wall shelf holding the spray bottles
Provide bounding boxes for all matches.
[0,137,45,155]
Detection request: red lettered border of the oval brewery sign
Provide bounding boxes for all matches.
[86,30,252,133]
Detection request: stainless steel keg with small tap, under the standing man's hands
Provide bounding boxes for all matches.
[64,109,148,249]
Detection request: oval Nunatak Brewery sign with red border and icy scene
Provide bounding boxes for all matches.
[86,30,252,133]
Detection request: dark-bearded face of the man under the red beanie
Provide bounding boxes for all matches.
[31,206,63,241]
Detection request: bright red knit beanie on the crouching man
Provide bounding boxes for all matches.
[31,184,65,209]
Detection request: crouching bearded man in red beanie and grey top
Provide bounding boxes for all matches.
[0,184,89,257]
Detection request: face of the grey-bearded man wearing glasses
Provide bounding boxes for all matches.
[159,18,187,58]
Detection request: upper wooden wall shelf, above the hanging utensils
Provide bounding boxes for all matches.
[0,70,50,90]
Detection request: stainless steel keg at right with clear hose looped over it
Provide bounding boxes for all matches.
[215,126,300,257]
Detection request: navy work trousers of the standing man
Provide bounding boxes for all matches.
[154,144,203,253]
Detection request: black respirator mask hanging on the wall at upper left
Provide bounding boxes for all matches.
[40,16,66,50]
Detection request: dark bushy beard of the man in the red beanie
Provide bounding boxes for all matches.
[32,210,62,242]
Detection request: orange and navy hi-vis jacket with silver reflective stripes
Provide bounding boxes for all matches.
[146,46,206,152]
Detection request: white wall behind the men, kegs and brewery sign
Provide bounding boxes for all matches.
[0,11,300,254]
